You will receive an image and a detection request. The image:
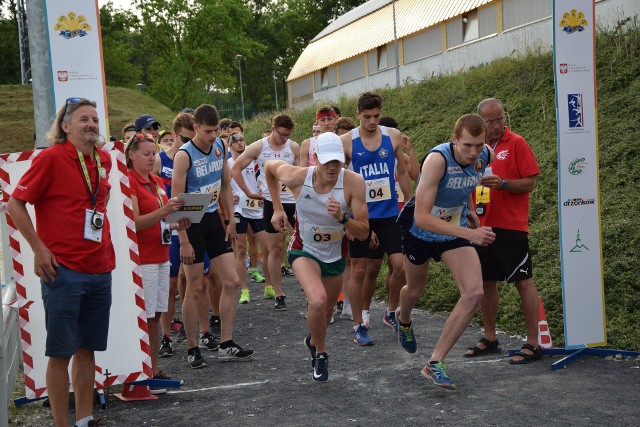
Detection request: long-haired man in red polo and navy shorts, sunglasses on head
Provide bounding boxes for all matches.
[8,98,115,427]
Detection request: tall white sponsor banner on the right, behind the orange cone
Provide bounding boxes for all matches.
[553,0,606,348]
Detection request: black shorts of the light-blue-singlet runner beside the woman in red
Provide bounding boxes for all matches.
[187,212,233,264]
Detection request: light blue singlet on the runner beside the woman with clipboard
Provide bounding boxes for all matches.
[180,138,224,213]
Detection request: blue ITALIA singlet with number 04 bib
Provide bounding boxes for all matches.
[351,126,398,218]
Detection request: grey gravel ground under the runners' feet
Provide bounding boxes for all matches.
[8,278,640,426]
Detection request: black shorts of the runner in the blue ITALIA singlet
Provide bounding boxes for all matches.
[349,216,402,259]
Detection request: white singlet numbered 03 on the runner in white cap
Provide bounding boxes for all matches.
[289,166,348,263]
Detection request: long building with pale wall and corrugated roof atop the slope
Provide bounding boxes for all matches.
[287,0,640,108]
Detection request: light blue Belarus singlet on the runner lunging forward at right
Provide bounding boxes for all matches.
[409,142,489,242]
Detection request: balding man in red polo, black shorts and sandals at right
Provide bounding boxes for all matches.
[465,98,542,364]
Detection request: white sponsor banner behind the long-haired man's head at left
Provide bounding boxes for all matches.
[41,0,109,141]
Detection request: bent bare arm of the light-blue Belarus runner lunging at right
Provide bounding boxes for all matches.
[414,153,495,246]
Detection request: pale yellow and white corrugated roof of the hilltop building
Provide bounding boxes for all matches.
[287,0,492,80]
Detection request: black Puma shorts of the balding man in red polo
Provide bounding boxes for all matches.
[476,227,533,283]
